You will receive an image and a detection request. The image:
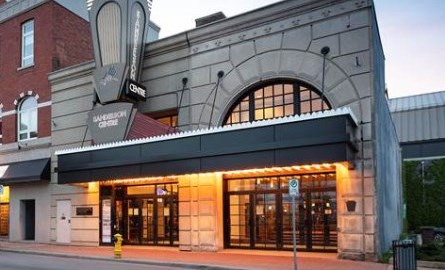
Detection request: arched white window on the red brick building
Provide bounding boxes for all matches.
[18,96,37,141]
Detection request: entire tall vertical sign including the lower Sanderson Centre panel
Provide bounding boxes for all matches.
[88,0,150,144]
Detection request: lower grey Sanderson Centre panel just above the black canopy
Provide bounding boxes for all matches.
[87,102,133,144]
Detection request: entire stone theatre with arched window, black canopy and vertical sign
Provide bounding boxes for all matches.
[49,0,402,260]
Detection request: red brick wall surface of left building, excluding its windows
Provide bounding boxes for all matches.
[0,0,93,144]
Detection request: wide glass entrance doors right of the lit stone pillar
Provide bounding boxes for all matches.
[224,173,337,251]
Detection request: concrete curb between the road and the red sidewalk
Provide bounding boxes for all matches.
[0,248,245,270]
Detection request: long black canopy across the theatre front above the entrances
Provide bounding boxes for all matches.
[58,112,355,184]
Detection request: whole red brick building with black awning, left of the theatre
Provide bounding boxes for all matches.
[0,0,93,242]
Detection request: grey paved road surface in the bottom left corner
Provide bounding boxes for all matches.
[0,252,186,270]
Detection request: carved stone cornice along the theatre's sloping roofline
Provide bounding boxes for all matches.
[146,0,372,57]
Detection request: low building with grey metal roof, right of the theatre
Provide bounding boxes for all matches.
[389,91,445,231]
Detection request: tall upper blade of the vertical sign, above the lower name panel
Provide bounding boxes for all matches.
[90,0,150,104]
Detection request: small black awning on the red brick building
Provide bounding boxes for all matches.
[0,158,50,185]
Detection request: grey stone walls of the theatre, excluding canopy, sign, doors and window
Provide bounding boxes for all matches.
[50,0,401,260]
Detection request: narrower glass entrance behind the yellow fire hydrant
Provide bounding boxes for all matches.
[101,183,179,246]
